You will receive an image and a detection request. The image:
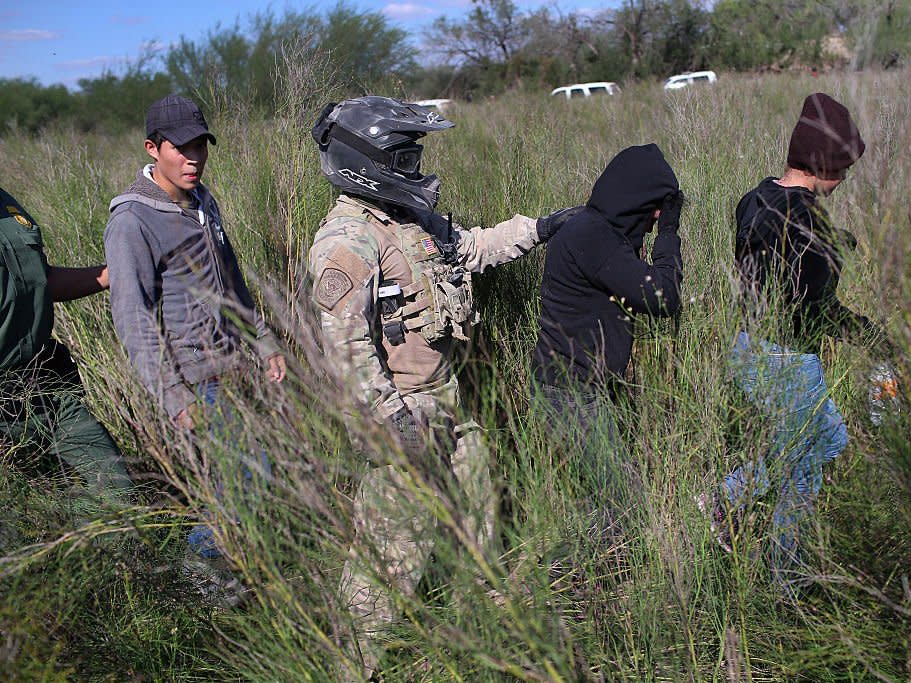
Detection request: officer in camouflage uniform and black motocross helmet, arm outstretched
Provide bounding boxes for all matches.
[309,97,577,671]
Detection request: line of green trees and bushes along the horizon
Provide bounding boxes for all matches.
[0,0,911,134]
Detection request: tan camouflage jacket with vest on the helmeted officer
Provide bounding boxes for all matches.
[309,195,538,420]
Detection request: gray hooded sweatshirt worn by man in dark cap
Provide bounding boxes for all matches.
[104,164,277,417]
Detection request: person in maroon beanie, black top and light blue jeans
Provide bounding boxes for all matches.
[697,93,886,597]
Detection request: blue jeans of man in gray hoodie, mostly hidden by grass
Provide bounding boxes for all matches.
[187,379,272,559]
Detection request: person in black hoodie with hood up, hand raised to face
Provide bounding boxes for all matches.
[532,144,683,504]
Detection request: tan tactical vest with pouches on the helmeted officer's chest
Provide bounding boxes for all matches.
[378,223,480,346]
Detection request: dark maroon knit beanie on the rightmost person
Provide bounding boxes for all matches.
[788,92,866,177]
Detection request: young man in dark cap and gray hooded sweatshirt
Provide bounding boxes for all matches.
[104,95,285,576]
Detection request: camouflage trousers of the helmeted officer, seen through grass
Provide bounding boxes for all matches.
[339,378,497,680]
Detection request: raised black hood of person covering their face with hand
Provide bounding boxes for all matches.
[588,144,680,250]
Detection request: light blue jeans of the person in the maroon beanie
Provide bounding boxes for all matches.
[722,332,848,581]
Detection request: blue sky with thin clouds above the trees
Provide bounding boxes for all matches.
[0,0,604,88]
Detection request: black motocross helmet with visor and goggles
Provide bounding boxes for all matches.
[311,96,455,211]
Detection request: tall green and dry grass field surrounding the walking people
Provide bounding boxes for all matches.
[0,65,911,682]
